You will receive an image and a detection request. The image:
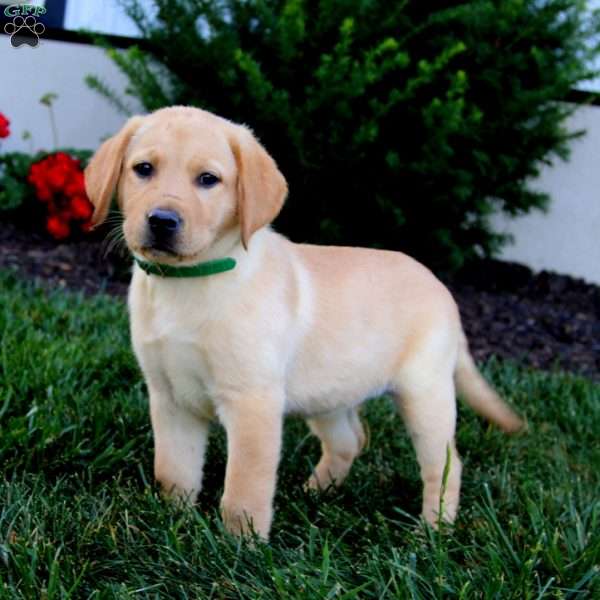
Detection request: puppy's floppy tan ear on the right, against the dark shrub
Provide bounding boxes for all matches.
[231,126,288,250]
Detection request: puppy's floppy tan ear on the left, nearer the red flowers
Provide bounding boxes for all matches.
[85,117,142,226]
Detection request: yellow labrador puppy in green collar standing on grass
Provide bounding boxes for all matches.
[85,107,522,538]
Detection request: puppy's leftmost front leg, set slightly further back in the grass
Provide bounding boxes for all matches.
[149,386,208,503]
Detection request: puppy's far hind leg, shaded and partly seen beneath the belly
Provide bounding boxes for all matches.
[306,408,366,490]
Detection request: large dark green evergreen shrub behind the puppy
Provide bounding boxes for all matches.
[88,0,598,267]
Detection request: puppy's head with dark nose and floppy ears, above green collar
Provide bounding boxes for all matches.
[85,107,287,264]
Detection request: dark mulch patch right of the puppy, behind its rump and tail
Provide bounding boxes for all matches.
[445,260,600,381]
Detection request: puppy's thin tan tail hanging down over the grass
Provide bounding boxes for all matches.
[454,334,525,433]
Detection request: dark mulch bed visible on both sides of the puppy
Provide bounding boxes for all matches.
[0,221,600,381]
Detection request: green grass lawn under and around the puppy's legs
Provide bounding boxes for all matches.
[0,273,600,600]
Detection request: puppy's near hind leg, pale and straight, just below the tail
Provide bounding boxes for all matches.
[396,369,461,527]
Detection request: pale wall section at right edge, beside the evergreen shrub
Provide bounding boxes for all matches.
[494,106,600,283]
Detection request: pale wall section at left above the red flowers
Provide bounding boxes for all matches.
[0,35,138,151]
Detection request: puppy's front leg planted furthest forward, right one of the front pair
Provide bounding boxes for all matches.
[218,393,283,539]
